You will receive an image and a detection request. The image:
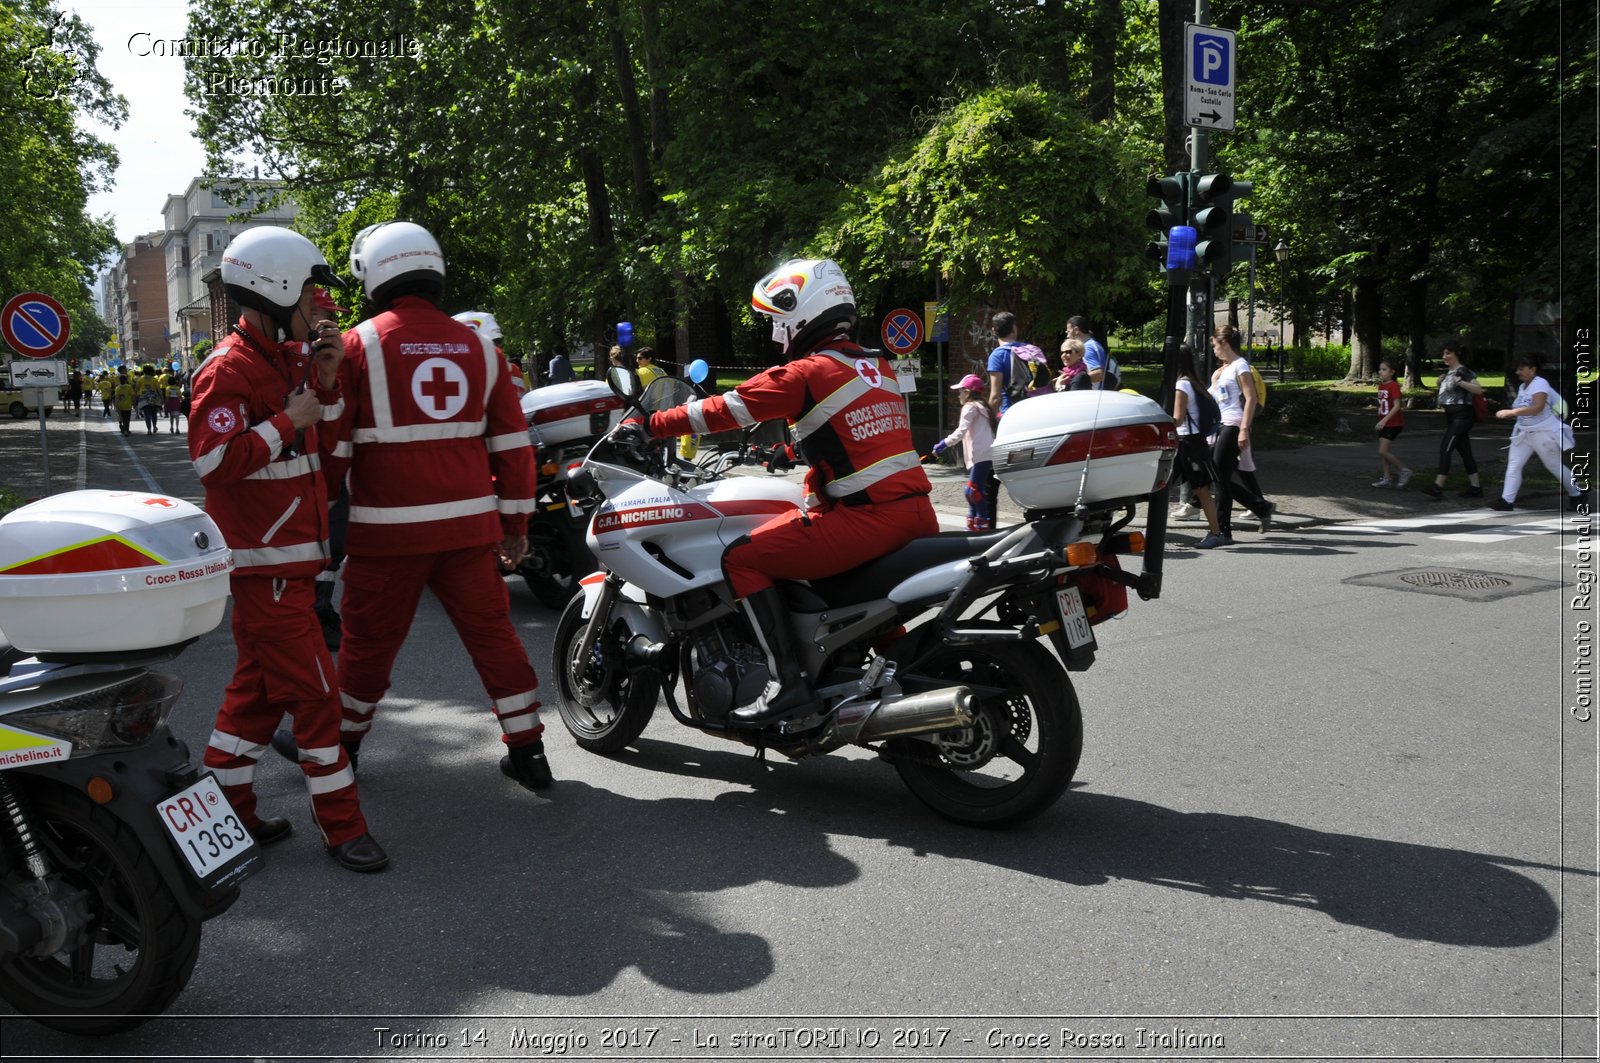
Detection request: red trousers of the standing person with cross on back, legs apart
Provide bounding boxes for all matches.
[339,546,544,746]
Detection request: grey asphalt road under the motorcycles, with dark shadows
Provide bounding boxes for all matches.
[0,405,1597,1060]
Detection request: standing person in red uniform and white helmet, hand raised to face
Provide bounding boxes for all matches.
[189,226,389,871]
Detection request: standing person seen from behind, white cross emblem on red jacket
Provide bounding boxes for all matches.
[323,221,550,789]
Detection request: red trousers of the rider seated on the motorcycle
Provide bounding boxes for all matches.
[722,495,939,597]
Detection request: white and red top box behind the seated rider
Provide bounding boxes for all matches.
[992,391,1178,509]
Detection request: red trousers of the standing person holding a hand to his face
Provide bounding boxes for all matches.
[205,573,366,845]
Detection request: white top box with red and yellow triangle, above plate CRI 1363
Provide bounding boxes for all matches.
[0,491,234,653]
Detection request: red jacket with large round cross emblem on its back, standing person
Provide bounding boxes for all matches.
[334,296,538,556]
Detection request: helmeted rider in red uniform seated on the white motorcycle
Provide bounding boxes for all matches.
[630,259,939,724]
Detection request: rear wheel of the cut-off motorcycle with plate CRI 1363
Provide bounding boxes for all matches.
[0,783,200,1034]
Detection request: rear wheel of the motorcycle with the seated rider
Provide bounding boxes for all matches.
[886,642,1083,828]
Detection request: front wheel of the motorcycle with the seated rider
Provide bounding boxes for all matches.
[550,597,661,752]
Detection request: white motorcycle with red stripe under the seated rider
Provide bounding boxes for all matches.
[552,365,1176,828]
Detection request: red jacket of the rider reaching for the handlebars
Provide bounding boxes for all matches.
[650,343,933,507]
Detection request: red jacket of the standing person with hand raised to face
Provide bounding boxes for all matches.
[189,320,342,576]
